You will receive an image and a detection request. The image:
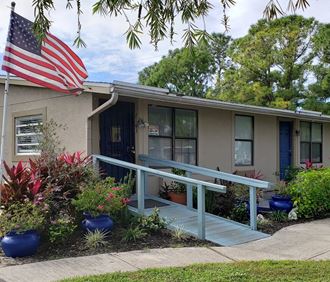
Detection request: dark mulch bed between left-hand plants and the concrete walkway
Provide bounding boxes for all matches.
[0,226,216,268]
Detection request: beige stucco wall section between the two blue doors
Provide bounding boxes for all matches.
[136,100,278,181]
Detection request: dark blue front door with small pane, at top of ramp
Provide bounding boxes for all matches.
[100,101,135,180]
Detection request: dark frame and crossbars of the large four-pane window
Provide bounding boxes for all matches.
[148,104,198,165]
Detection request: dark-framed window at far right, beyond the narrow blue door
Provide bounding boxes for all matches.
[300,121,322,163]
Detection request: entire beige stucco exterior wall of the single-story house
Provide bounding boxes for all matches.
[0,84,330,186]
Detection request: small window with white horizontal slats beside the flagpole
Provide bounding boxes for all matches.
[15,114,42,155]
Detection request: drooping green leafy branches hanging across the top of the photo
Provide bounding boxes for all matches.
[32,0,309,48]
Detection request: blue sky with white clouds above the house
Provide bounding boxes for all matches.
[0,0,330,83]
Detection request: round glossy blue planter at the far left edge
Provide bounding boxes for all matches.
[1,230,40,258]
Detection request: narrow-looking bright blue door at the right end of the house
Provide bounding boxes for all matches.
[280,121,292,180]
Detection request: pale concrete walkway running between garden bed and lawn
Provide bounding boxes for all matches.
[0,219,330,282]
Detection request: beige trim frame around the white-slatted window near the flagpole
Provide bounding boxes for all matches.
[12,108,46,161]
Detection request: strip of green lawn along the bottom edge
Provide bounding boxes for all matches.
[63,261,330,282]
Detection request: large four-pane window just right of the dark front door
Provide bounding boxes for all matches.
[149,106,197,164]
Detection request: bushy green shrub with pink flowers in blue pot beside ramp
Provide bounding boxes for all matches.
[72,177,129,217]
